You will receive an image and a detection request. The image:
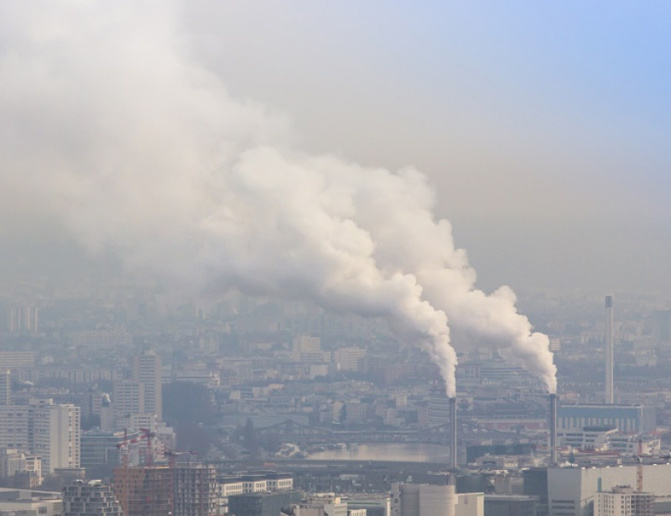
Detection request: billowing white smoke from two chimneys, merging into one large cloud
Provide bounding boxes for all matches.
[0,1,555,395]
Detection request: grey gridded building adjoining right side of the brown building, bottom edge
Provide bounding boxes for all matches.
[173,463,220,516]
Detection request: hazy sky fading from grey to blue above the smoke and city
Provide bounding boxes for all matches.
[0,0,671,298]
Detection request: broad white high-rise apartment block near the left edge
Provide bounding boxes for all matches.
[32,404,81,473]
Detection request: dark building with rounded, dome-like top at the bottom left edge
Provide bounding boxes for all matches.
[62,480,123,516]
